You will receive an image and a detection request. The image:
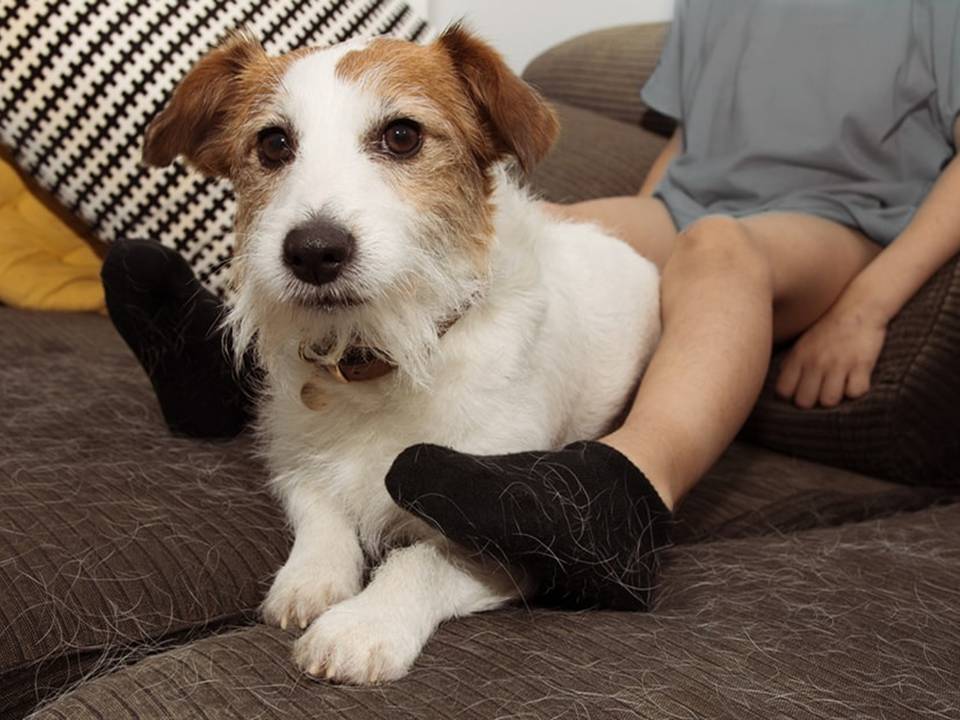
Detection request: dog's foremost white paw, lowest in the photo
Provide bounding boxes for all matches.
[293,598,426,685]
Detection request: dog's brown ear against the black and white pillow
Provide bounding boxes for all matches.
[143,32,266,177]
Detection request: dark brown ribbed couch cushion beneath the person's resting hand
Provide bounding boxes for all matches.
[744,258,960,486]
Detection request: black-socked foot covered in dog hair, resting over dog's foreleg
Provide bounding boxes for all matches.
[386,442,673,610]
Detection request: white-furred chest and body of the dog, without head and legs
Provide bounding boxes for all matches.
[261,188,659,554]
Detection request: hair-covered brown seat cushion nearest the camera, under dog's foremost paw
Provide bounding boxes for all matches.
[34,507,960,720]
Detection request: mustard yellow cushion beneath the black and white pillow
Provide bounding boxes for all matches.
[0,159,104,311]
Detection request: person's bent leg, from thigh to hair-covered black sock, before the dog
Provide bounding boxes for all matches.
[386,207,876,609]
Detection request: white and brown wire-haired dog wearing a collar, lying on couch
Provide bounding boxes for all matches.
[144,25,660,684]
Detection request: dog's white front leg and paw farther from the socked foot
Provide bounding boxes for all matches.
[261,484,363,628]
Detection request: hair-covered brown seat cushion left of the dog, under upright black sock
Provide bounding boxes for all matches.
[0,308,288,719]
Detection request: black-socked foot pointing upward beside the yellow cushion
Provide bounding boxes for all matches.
[101,240,256,438]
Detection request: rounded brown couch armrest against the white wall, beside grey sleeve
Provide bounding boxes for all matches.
[523,23,674,135]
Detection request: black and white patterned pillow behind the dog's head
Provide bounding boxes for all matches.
[0,0,427,293]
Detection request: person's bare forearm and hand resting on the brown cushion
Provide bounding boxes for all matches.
[777,119,960,407]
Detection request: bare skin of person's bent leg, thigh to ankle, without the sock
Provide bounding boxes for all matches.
[602,213,877,508]
